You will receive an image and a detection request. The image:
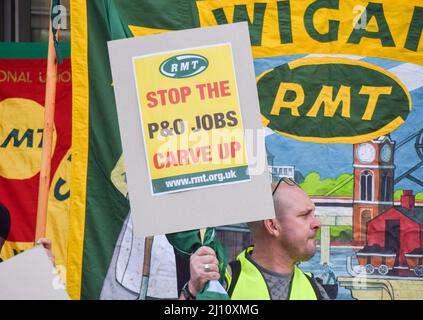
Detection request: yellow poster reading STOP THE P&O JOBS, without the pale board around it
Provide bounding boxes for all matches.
[133,44,249,194]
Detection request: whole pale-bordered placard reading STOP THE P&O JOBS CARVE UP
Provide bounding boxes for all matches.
[109,23,274,235]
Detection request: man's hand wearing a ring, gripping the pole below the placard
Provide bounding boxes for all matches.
[188,246,220,296]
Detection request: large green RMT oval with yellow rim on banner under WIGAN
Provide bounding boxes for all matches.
[257,57,411,143]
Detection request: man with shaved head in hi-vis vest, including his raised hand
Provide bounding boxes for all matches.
[182,178,329,300]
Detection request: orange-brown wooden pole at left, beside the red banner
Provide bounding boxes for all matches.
[35,0,57,241]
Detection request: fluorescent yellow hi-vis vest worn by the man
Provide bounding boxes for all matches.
[226,246,321,300]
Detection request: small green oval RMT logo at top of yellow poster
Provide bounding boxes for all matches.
[160,53,209,78]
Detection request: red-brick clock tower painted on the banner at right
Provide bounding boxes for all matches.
[353,135,395,245]
